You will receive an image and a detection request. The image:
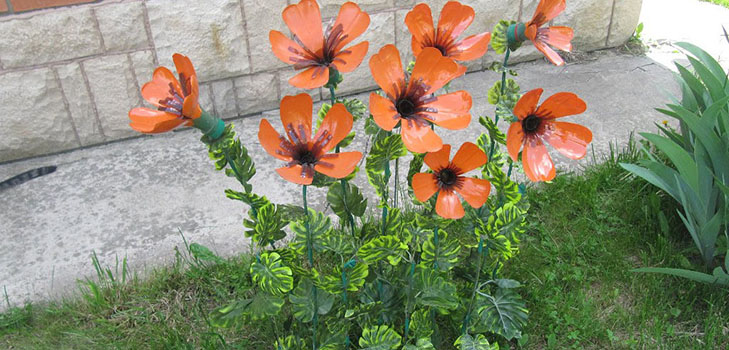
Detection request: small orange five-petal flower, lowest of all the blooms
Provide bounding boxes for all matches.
[413,142,491,219]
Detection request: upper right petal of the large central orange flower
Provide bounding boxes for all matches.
[408,47,461,95]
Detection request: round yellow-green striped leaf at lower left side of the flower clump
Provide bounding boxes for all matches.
[251,252,294,295]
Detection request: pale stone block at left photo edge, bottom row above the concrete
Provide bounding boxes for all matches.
[0,68,80,161]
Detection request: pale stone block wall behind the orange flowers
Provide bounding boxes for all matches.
[0,0,642,162]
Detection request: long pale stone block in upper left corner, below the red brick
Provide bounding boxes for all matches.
[0,7,103,69]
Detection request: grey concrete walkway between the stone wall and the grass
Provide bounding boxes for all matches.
[0,52,677,304]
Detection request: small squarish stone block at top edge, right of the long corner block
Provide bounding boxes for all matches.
[94,2,149,51]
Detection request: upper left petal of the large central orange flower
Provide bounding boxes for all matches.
[370,44,405,100]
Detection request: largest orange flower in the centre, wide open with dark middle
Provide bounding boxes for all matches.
[370,45,471,153]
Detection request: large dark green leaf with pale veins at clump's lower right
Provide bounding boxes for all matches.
[478,288,529,340]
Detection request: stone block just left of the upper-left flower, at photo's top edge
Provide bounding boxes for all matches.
[243,0,289,72]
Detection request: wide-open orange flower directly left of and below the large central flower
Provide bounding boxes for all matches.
[258,94,362,185]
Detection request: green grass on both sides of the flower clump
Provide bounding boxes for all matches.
[0,145,729,349]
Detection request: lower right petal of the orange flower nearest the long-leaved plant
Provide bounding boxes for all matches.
[544,121,592,159]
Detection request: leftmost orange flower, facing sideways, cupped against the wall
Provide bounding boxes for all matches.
[129,53,202,134]
